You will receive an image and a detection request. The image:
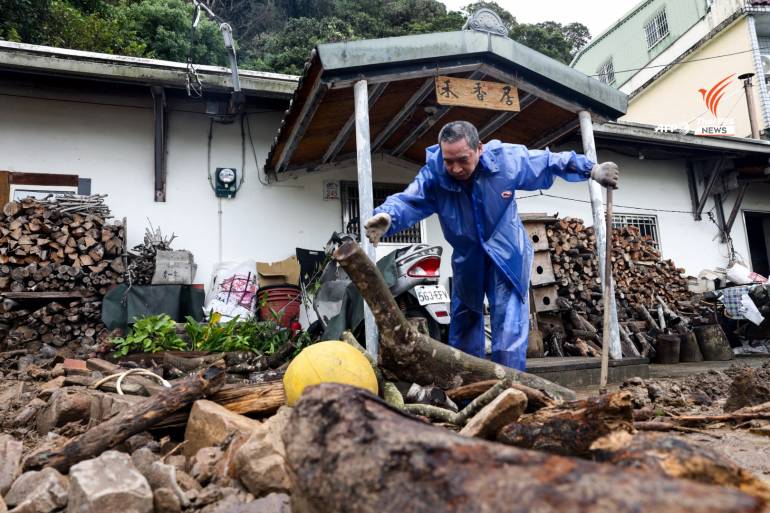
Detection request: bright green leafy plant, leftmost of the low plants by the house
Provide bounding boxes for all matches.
[112,314,187,357]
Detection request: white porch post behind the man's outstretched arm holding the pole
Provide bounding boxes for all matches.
[578,111,623,360]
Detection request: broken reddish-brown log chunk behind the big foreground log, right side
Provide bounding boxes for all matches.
[497,392,634,457]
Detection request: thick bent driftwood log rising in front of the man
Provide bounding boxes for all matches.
[334,241,575,400]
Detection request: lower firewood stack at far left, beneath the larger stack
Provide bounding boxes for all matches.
[0,298,107,354]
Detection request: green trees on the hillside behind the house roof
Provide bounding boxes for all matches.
[0,0,589,74]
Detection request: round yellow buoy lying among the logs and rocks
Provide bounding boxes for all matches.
[283,340,377,406]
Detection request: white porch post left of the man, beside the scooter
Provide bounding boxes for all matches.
[353,80,379,360]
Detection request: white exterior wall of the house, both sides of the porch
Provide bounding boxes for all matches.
[0,84,770,300]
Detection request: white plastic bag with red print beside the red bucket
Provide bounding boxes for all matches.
[203,260,257,320]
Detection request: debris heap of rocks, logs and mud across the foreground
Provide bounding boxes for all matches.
[0,243,770,513]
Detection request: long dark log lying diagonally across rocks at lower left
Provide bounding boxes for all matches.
[24,367,225,473]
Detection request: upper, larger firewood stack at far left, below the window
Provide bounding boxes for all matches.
[0,198,125,294]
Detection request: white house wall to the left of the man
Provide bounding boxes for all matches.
[0,86,426,290]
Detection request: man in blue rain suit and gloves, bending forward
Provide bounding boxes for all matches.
[365,121,618,370]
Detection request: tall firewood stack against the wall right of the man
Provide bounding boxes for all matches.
[543,217,715,363]
